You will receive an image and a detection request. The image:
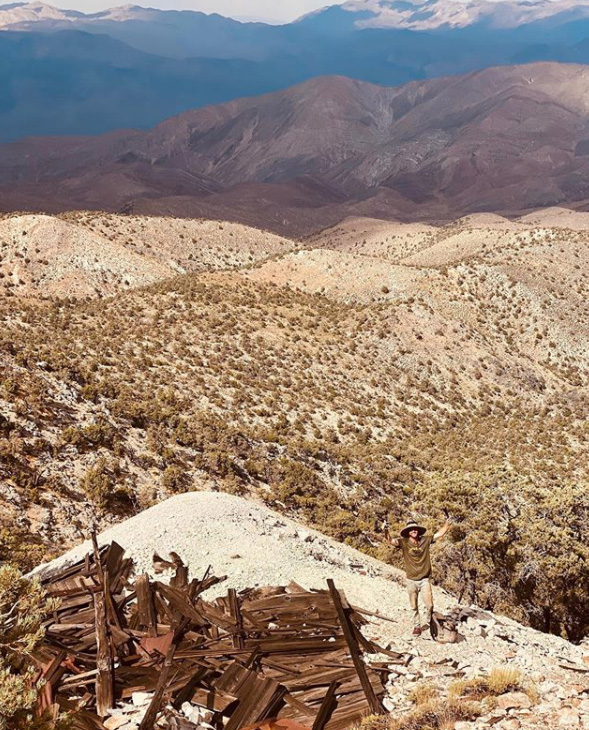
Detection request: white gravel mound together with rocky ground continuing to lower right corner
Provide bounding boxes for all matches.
[40,492,589,730]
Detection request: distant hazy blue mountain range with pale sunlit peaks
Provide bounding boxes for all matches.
[0,0,589,141]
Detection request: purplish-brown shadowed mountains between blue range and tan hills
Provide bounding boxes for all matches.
[0,63,589,236]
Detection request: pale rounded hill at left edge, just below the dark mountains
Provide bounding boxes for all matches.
[0,213,295,298]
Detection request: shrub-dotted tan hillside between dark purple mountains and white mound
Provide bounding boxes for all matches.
[0,210,589,640]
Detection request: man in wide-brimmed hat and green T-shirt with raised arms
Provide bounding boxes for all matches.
[390,520,451,636]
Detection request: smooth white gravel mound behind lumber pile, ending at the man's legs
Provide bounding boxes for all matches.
[41,492,428,614]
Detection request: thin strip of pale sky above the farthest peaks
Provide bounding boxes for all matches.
[49,0,344,22]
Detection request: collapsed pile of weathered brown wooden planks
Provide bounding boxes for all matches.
[34,541,408,730]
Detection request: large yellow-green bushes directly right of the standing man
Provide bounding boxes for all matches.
[415,468,589,641]
